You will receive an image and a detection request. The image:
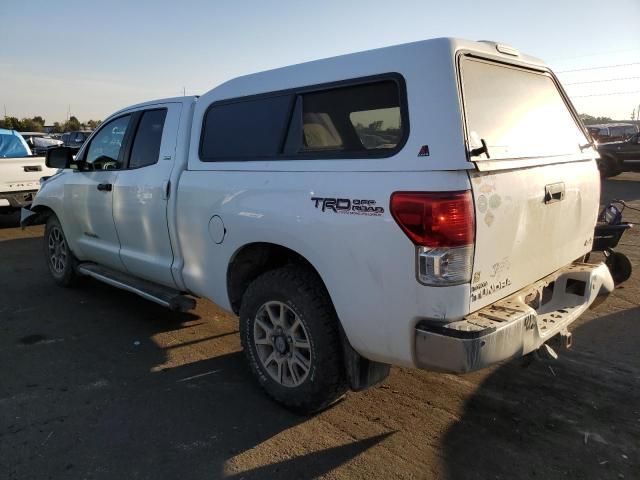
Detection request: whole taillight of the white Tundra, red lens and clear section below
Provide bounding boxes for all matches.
[391,190,475,286]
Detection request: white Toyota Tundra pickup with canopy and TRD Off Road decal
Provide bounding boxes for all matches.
[22,39,613,411]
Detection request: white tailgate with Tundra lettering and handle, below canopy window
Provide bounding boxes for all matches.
[471,160,600,311]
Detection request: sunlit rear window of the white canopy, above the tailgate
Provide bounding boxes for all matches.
[461,57,589,160]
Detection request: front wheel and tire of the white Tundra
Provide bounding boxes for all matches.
[43,215,78,287]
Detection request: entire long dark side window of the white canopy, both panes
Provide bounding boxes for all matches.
[200,74,408,161]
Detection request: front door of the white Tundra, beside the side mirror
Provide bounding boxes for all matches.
[63,114,132,270]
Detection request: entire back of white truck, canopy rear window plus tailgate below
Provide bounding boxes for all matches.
[459,54,600,311]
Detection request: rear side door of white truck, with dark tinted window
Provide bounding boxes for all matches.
[113,103,182,286]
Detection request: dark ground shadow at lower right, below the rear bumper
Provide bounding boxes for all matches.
[443,307,640,480]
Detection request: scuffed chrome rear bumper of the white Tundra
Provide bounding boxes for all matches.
[415,263,613,373]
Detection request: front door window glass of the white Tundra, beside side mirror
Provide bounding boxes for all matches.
[85,115,131,170]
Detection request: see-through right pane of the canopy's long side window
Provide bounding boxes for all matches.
[302,80,402,152]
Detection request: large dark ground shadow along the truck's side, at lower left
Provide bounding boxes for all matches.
[0,238,386,479]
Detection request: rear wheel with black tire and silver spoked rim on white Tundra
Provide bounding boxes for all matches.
[240,265,347,414]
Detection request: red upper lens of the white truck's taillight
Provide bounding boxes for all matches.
[391,190,475,248]
